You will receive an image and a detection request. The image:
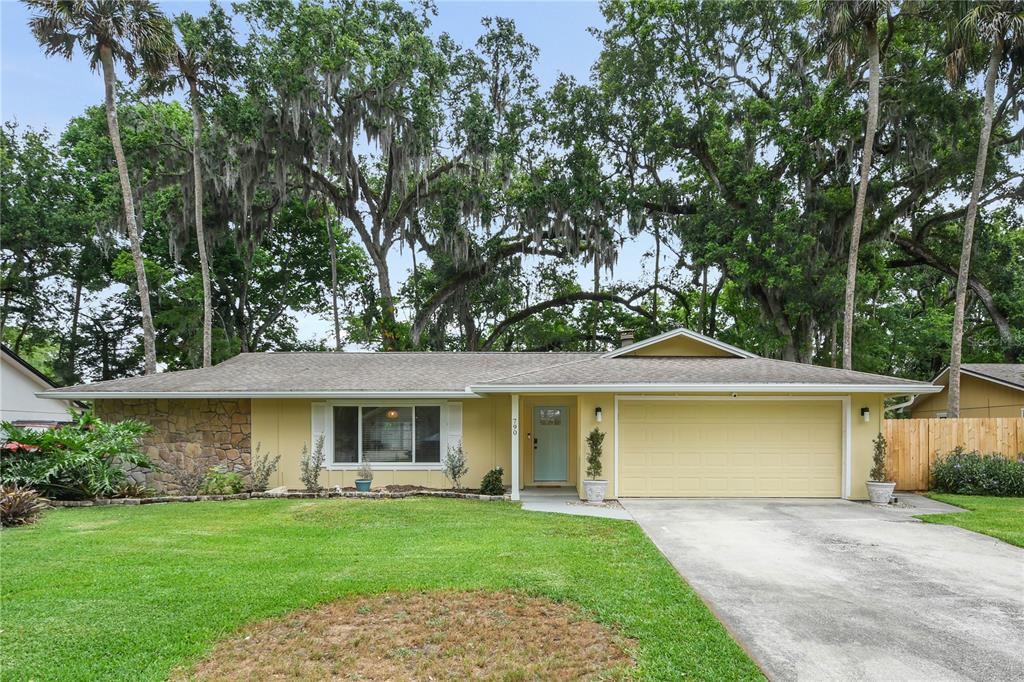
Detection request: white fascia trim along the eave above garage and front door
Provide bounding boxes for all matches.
[469,384,942,395]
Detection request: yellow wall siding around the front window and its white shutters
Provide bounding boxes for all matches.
[252,395,512,488]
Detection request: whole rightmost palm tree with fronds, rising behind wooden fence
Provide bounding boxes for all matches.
[946,0,1024,418]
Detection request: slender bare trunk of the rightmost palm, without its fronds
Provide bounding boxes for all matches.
[948,38,1002,418]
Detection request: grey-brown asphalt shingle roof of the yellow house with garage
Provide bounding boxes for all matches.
[47,352,928,396]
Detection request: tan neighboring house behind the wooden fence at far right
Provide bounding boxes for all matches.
[908,363,1024,419]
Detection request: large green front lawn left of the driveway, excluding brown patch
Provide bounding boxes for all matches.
[0,498,761,680]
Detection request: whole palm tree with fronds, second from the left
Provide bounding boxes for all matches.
[163,2,238,367]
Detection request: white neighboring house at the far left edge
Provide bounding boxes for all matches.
[0,344,72,428]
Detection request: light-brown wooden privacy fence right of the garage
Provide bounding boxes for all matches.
[884,417,1024,491]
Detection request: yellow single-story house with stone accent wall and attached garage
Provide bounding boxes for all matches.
[37,329,940,500]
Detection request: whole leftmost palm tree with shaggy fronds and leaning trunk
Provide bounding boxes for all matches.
[24,0,174,374]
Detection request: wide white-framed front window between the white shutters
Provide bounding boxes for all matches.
[334,404,441,464]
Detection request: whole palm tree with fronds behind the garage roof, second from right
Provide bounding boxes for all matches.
[820,0,888,370]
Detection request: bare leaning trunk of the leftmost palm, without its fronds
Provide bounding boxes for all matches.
[99,45,157,374]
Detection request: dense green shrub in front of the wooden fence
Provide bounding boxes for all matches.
[932,447,1024,498]
